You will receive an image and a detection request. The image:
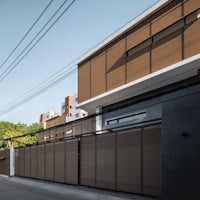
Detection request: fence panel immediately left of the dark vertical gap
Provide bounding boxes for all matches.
[65,139,78,185]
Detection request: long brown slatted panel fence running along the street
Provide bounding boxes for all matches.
[15,125,161,196]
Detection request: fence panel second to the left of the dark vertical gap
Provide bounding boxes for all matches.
[55,141,65,182]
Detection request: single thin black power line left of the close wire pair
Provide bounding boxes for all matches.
[0,0,53,69]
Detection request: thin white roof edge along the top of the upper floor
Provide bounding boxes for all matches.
[77,0,171,65]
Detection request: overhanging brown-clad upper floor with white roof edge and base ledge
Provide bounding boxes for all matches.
[78,0,200,111]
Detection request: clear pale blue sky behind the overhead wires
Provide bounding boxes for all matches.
[0,0,158,124]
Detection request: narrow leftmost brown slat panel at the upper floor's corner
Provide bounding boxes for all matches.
[78,62,91,102]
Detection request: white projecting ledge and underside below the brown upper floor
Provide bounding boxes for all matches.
[78,54,200,111]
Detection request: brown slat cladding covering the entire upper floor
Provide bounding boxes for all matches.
[79,0,200,103]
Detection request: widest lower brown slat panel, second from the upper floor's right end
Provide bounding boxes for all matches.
[152,36,182,72]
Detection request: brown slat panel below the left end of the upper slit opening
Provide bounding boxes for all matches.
[126,52,150,82]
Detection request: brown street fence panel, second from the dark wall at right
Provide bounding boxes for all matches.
[116,128,141,193]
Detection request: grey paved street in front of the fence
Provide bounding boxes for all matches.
[0,176,156,200]
